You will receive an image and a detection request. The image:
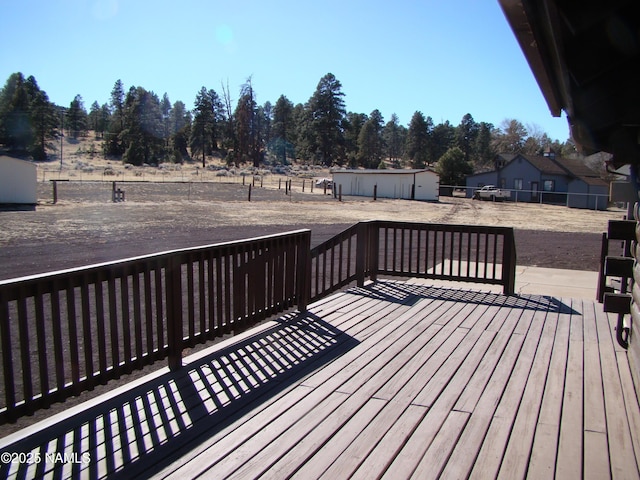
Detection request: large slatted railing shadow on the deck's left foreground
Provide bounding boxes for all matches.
[0,313,357,478]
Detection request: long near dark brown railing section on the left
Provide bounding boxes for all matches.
[0,230,311,423]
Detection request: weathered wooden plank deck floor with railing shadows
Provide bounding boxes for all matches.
[0,281,640,479]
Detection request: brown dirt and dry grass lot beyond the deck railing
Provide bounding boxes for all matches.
[0,179,625,279]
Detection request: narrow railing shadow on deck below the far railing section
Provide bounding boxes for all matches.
[349,280,581,315]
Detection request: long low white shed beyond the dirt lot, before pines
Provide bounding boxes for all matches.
[332,169,440,201]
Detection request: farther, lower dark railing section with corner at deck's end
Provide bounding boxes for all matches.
[311,221,516,300]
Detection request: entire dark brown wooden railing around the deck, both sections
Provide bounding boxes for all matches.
[0,221,515,423]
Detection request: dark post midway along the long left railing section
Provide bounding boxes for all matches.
[165,255,183,370]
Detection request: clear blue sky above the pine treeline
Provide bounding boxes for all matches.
[0,0,569,141]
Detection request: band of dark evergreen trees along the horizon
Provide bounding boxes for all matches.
[0,73,575,174]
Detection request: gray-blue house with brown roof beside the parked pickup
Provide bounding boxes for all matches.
[467,152,609,210]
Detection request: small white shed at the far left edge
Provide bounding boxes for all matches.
[0,156,38,205]
